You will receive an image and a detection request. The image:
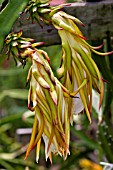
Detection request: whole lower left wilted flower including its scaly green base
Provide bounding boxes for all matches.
[5,32,78,162]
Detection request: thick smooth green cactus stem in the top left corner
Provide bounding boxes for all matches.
[0,0,29,51]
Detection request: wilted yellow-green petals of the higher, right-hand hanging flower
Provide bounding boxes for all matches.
[52,11,113,122]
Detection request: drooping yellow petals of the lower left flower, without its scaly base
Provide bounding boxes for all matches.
[26,50,73,161]
